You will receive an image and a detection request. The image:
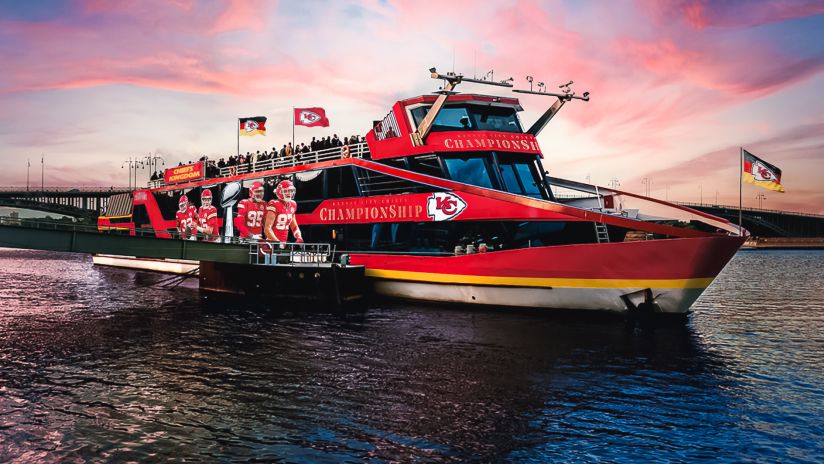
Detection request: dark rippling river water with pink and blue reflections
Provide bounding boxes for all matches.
[0,249,824,462]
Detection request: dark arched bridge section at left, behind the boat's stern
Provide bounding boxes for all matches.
[0,187,131,222]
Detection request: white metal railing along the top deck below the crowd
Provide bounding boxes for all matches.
[148,142,369,188]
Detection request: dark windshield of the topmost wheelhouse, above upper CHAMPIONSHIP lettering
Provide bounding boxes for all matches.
[412,105,523,133]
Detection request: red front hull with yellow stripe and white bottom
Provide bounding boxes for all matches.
[352,236,744,314]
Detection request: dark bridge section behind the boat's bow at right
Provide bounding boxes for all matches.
[675,202,824,238]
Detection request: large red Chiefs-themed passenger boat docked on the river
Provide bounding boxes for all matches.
[99,68,747,314]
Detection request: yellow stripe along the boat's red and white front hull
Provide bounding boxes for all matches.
[365,268,713,289]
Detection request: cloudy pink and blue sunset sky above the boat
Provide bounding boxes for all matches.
[0,0,824,213]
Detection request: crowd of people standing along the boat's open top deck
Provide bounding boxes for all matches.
[150,134,366,181]
